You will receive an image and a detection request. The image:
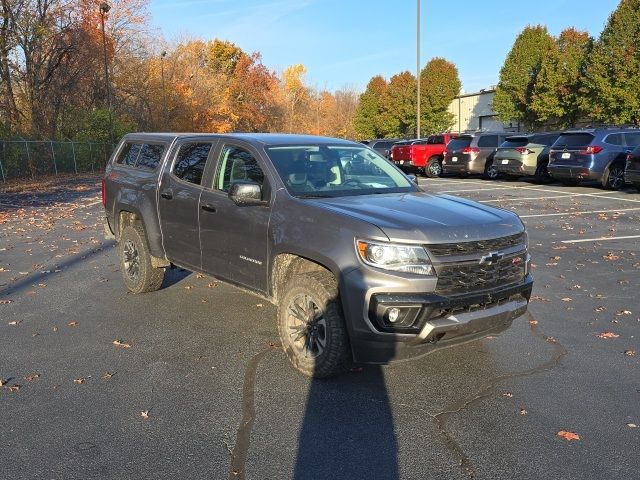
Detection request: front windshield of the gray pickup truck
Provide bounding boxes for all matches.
[266,145,415,198]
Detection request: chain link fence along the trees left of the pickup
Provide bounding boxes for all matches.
[0,140,113,182]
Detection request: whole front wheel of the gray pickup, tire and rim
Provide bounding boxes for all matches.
[278,272,350,378]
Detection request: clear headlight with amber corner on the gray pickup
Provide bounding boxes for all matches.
[356,240,435,275]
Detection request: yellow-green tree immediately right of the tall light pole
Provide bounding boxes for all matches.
[420,58,462,134]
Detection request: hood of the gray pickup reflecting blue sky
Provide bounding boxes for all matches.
[314,192,524,244]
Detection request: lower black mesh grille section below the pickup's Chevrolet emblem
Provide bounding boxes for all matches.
[436,254,527,295]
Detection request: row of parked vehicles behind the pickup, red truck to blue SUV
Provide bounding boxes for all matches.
[372,127,640,190]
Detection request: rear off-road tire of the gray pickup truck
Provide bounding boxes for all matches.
[118,223,164,294]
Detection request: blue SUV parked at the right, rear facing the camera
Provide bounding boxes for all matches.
[548,127,640,190]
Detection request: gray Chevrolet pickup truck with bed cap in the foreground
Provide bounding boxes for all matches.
[102,133,533,378]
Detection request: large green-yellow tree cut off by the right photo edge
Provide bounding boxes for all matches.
[580,0,640,125]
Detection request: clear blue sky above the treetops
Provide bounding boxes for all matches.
[150,0,618,92]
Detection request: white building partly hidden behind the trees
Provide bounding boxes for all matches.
[449,87,520,132]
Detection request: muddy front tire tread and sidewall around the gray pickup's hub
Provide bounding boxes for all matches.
[278,272,351,378]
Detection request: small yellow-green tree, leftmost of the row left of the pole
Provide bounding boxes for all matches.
[353,75,388,139]
